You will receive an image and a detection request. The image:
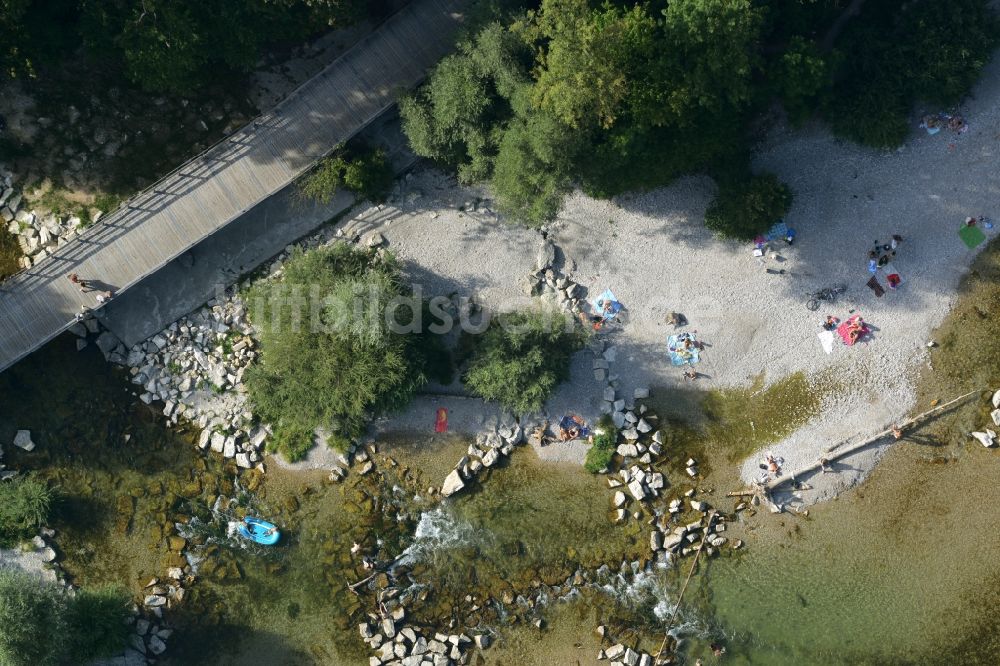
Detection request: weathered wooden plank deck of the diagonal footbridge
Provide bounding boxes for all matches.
[0,0,467,370]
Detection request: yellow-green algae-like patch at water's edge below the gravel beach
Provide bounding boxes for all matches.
[702,372,821,461]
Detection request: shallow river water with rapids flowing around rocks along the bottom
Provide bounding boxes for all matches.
[0,245,1000,665]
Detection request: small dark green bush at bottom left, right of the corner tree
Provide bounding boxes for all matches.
[67,585,132,662]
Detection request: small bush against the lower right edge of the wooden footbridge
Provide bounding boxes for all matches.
[299,148,395,204]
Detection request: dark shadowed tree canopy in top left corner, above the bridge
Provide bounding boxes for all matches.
[0,0,379,94]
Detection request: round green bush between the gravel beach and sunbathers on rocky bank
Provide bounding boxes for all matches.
[464,311,586,414]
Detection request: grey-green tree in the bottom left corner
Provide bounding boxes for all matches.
[0,569,70,666]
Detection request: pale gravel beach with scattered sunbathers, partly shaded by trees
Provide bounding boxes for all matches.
[344,53,1000,500]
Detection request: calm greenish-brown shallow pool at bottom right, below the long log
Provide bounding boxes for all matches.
[705,428,1000,664]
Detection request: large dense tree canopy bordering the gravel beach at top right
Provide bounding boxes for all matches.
[401,0,998,235]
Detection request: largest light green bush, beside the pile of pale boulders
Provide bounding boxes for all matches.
[246,243,440,460]
